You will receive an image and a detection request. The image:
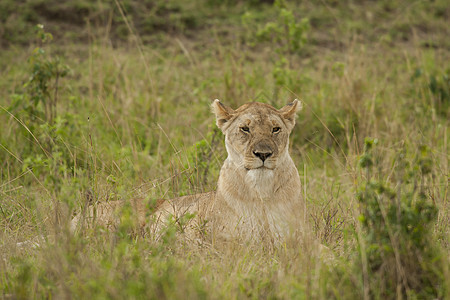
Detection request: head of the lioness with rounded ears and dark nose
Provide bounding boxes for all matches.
[212,100,302,170]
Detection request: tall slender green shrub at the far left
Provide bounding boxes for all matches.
[8,24,76,173]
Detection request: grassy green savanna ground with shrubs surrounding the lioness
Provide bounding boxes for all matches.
[0,0,450,299]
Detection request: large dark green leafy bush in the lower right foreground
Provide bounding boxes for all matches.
[357,138,442,299]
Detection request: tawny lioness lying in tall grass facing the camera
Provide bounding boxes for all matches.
[73,100,304,243]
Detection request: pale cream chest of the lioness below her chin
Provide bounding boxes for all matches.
[212,162,301,238]
